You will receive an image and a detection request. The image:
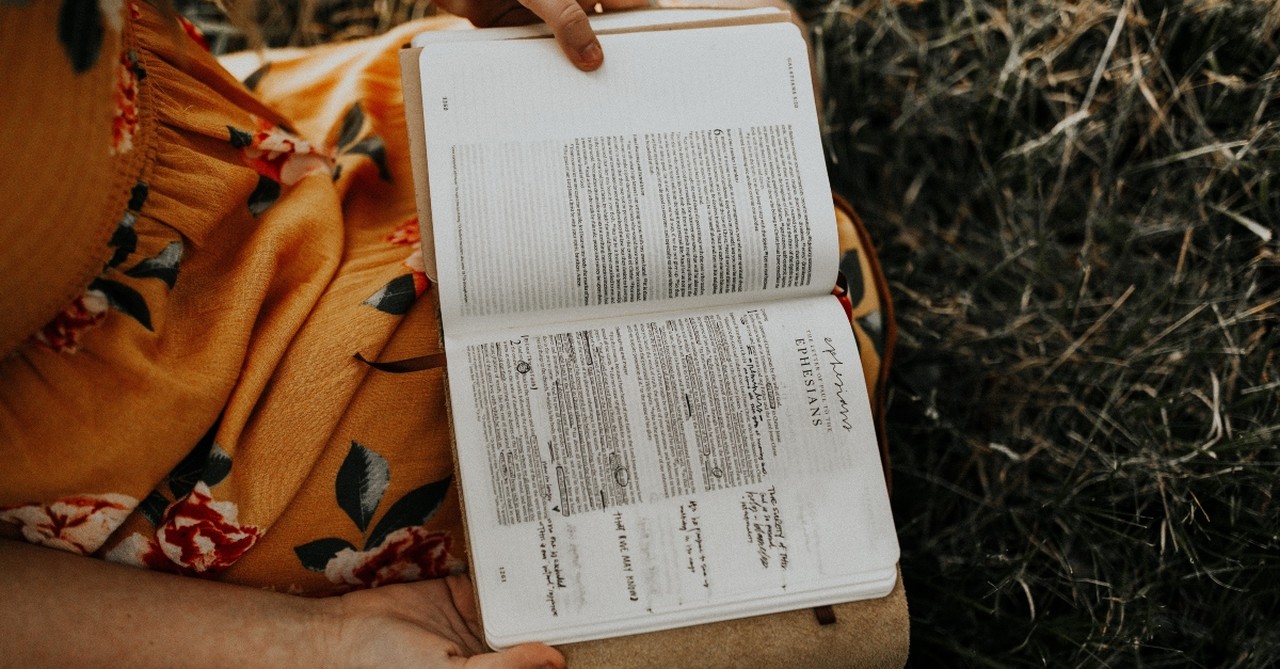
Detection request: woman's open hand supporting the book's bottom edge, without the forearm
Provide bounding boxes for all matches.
[326,576,564,669]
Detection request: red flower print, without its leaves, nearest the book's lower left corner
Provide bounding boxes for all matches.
[324,527,456,587]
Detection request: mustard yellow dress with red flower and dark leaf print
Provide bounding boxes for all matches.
[0,0,892,595]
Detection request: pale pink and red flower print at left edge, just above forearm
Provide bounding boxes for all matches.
[0,492,138,555]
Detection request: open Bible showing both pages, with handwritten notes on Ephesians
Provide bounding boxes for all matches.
[407,12,899,647]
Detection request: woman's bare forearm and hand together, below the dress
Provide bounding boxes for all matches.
[0,539,564,669]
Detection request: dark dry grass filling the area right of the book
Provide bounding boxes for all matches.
[804,0,1280,666]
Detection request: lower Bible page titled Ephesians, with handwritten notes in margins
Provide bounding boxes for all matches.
[447,295,899,647]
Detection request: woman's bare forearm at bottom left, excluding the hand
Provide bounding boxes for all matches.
[0,540,337,669]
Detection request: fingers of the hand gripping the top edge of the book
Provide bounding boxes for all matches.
[436,0,650,72]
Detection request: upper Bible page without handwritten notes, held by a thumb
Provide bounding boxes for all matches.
[420,23,837,333]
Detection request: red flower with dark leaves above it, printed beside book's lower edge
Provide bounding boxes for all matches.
[293,441,462,587]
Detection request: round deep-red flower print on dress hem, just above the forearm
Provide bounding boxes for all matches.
[156,481,262,573]
